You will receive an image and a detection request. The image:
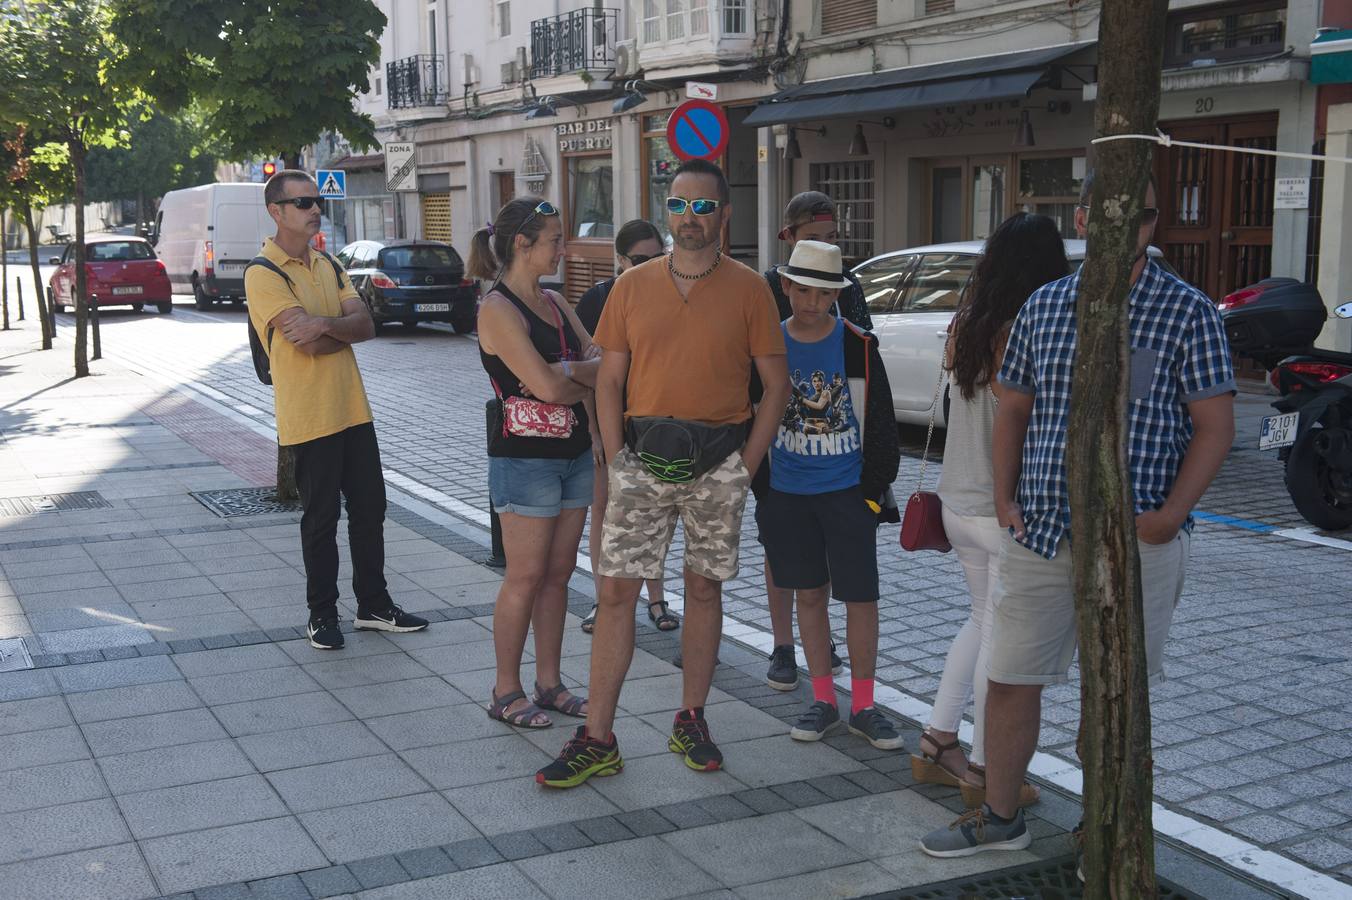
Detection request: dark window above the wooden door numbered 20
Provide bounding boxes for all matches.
[1164,0,1286,66]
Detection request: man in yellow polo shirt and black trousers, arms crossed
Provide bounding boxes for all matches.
[245,169,427,650]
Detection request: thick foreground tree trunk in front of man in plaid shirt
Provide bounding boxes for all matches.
[1065,0,1168,900]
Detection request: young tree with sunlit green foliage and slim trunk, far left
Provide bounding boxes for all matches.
[0,0,135,378]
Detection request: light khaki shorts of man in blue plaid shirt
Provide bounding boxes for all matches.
[986,531,1191,684]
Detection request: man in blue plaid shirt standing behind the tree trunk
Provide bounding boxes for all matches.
[921,178,1234,857]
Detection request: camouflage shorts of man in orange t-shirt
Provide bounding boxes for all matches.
[596,447,752,581]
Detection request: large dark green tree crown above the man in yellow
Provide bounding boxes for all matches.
[110,0,385,159]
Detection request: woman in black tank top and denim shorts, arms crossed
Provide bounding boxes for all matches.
[468,199,600,728]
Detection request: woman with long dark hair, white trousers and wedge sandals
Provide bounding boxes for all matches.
[911,212,1068,805]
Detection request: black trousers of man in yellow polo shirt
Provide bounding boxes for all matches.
[292,422,391,618]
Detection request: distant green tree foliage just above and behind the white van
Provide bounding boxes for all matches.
[85,107,218,222]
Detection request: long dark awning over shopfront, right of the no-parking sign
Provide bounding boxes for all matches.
[745,41,1095,126]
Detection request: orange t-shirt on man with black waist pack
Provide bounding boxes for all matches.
[595,257,784,426]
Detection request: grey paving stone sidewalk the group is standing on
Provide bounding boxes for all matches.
[0,312,1308,900]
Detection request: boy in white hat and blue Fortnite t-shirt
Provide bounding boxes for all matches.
[756,241,902,750]
